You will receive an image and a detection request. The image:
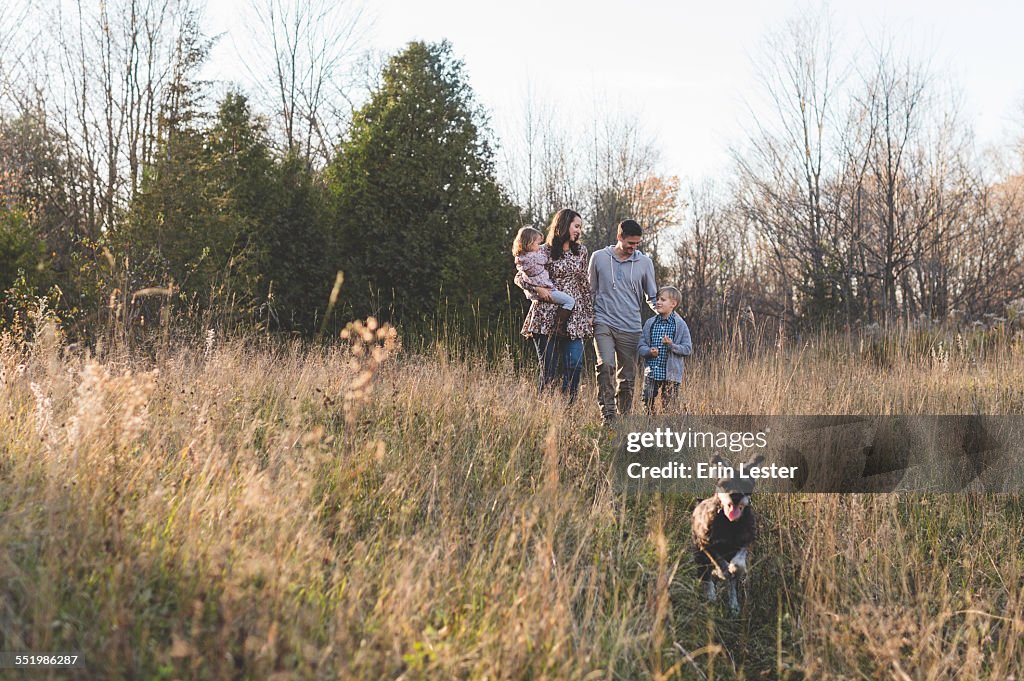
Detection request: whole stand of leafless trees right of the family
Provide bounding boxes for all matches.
[676,7,1024,331]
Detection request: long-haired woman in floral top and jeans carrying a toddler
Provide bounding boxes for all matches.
[522,208,594,403]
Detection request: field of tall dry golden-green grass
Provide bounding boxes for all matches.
[0,325,1024,679]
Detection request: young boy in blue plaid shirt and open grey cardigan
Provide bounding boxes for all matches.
[637,286,693,414]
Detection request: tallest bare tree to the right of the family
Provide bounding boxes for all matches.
[733,5,842,323]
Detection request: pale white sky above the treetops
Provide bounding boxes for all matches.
[201,0,1024,180]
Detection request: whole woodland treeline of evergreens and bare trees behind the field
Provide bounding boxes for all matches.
[0,0,1024,341]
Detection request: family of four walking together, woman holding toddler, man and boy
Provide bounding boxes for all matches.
[512,208,692,424]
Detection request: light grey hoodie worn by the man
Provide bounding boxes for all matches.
[589,246,657,333]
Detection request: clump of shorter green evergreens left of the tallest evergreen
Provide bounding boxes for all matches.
[123,93,337,332]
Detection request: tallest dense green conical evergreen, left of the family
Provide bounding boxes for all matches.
[330,41,517,321]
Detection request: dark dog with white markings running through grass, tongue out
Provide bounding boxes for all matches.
[692,455,764,614]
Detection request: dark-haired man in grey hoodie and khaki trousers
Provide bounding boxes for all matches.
[589,220,657,424]
